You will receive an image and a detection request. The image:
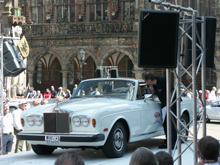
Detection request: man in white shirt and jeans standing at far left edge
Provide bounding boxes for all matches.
[0,103,14,155]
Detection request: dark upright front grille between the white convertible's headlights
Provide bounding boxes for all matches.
[44,113,70,133]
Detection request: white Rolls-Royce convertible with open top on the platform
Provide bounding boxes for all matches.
[18,78,193,157]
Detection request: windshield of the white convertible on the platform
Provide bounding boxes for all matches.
[71,80,135,100]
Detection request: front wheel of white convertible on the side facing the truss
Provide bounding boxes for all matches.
[102,122,127,158]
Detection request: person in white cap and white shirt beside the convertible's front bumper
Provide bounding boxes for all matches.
[12,100,31,153]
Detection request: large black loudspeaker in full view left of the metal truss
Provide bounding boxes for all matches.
[138,10,179,68]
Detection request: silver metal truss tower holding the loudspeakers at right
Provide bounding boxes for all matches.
[151,0,206,165]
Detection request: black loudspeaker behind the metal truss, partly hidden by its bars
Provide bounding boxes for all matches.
[182,17,217,68]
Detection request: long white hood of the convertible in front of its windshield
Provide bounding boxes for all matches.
[23,97,131,115]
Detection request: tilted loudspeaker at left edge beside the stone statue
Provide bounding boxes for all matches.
[3,41,26,77]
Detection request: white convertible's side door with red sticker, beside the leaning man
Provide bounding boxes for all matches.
[140,99,161,134]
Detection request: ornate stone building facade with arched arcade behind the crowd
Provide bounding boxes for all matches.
[0,0,220,96]
